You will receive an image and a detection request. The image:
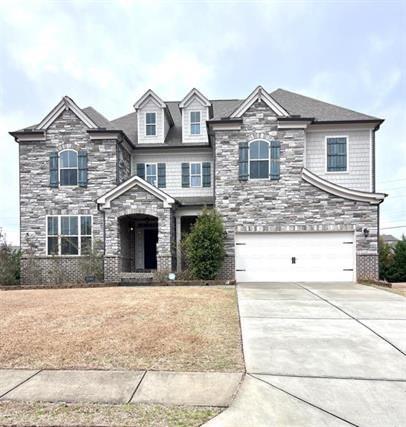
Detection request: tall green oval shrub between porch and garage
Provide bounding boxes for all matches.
[182,209,225,280]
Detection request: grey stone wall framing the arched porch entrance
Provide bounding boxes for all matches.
[105,186,174,282]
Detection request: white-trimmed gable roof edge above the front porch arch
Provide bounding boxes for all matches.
[96,175,175,209]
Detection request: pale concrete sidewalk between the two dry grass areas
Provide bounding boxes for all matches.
[0,369,243,407]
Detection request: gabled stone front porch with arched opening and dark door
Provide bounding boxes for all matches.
[98,176,202,283]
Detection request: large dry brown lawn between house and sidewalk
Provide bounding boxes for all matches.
[0,287,244,371]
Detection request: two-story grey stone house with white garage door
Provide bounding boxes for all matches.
[11,87,385,283]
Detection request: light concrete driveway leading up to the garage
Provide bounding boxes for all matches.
[207,283,406,427]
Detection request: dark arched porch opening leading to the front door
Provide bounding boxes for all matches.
[118,214,158,273]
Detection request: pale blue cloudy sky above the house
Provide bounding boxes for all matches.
[0,0,406,244]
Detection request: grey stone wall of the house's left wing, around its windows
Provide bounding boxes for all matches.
[19,110,117,284]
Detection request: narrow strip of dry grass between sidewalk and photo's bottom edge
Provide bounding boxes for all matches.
[0,401,221,427]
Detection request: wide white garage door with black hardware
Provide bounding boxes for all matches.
[235,232,355,282]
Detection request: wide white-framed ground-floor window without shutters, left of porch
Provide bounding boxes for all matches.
[47,215,92,255]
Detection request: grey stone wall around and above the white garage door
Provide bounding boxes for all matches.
[215,102,378,280]
